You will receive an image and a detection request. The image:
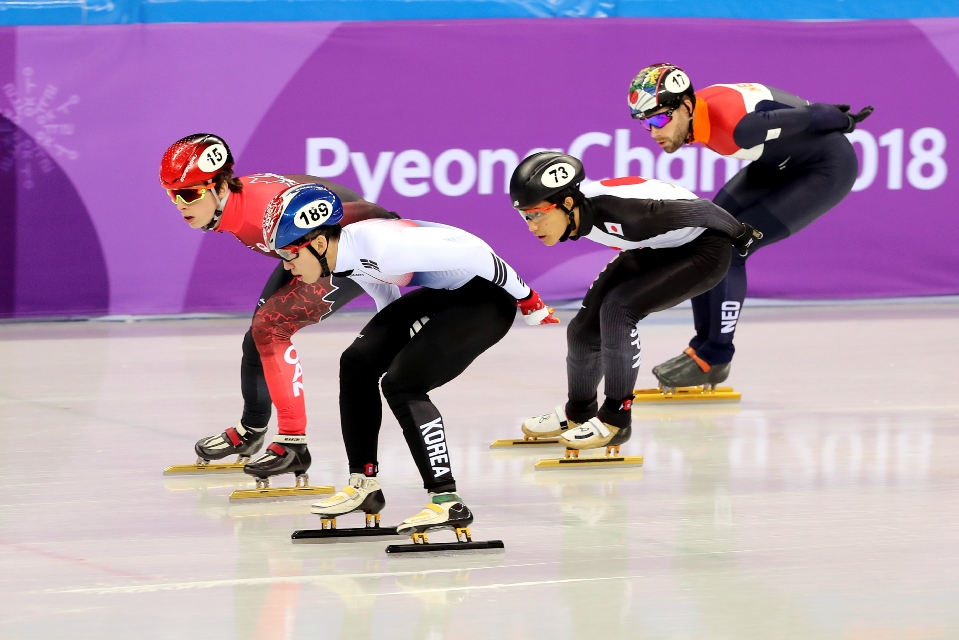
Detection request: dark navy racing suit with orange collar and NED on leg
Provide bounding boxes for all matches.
[689,83,859,365]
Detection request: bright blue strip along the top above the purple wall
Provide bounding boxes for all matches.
[0,0,959,26]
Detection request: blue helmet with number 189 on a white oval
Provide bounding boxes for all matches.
[263,184,343,251]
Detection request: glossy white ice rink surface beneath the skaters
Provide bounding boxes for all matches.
[0,302,959,640]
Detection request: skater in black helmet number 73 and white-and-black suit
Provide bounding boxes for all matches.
[510,152,757,449]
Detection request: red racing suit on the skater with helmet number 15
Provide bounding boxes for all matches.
[216,173,398,435]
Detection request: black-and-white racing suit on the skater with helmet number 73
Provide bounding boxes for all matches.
[566,178,744,428]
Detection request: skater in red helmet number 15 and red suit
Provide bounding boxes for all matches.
[160,133,398,478]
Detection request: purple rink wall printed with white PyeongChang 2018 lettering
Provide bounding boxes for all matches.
[0,19,959,317]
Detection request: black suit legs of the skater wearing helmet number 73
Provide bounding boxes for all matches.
[566,231,731,427]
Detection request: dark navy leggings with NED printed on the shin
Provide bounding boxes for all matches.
[689,133,859,364]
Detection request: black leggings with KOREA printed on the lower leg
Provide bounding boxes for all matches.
[340,278,516,493]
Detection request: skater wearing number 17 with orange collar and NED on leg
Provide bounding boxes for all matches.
[629,63,873,388]
